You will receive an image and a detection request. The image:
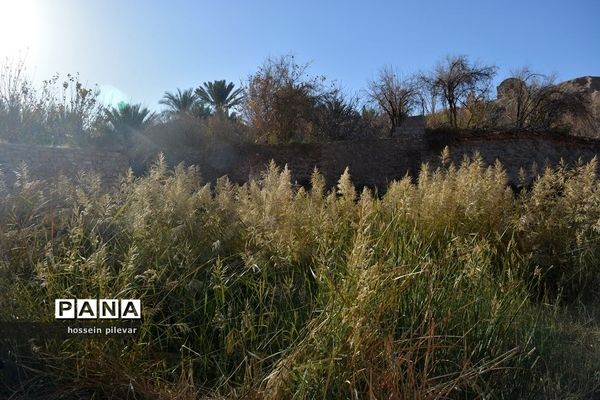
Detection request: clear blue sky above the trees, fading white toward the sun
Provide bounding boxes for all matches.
[0,0,600,109]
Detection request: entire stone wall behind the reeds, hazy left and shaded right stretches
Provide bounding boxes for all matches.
[0,132,600,192]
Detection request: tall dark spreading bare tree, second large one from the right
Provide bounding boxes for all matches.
[420,55,497,128]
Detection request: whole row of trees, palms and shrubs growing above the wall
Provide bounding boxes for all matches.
[0,55,600,150]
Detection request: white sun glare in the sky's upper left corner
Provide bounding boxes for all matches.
[0,0,38,59]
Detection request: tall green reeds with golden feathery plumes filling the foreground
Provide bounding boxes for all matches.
[0,152,600,399]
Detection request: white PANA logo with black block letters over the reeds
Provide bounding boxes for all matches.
[54,299,142,319]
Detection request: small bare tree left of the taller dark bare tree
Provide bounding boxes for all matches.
[367,67,419,134]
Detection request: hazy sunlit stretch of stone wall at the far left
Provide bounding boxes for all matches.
[0,143,129,188]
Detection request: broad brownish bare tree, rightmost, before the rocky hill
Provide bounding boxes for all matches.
[498,67,588,129]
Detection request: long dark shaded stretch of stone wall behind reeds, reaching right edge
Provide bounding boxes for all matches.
[166,133,600,191]
